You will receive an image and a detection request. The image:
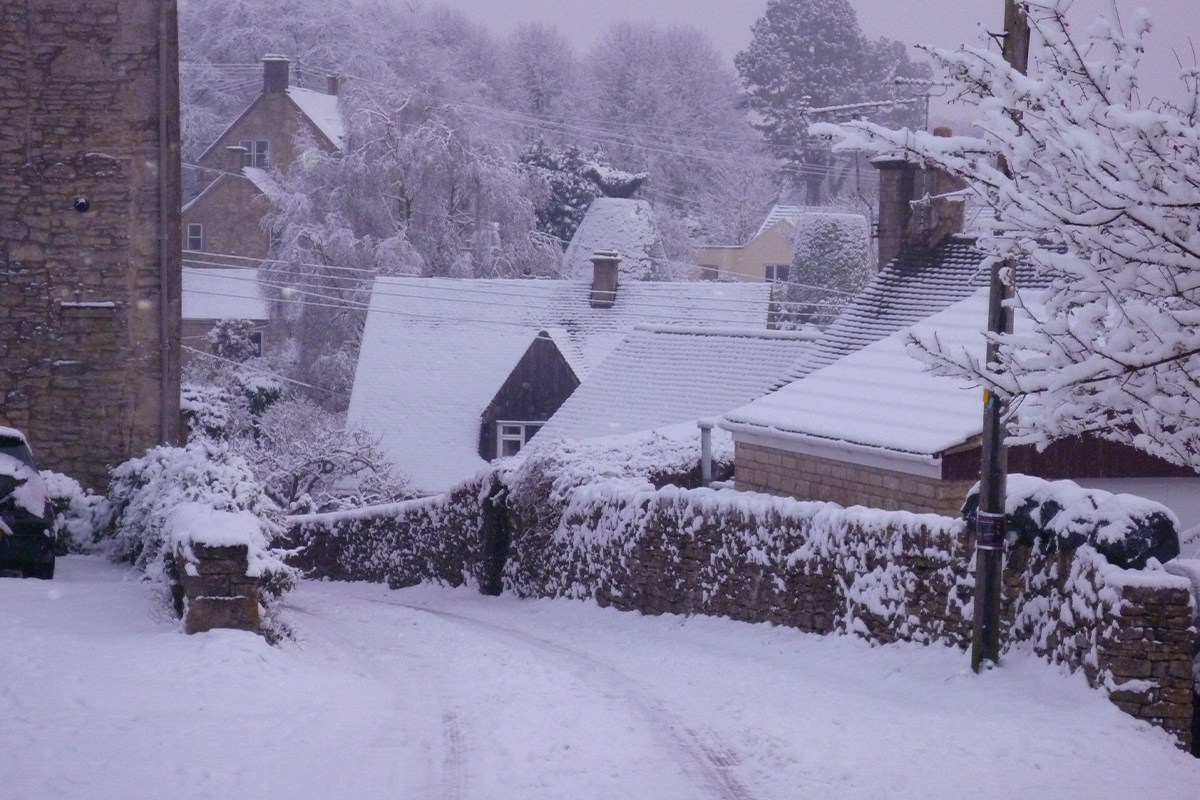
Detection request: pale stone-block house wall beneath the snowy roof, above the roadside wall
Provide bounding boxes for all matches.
[734,441,974,517]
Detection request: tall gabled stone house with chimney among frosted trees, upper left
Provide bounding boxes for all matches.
[182,55,346,266]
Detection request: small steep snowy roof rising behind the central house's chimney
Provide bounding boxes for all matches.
[563,197,666,281]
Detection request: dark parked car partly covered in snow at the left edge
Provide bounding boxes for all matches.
[0,427,54,579]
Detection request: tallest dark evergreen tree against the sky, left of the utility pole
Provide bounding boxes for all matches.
[734,0,929,205]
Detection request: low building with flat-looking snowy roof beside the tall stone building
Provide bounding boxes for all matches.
[182,266,270,363]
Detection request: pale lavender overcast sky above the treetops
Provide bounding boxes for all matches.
[428,0,1200,112]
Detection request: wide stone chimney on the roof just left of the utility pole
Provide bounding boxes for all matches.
[872,127,966,269]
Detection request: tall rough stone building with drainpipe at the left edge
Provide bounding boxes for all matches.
[0,0,180,488]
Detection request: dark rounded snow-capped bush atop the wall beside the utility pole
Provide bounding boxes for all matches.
[962,474,1180,570]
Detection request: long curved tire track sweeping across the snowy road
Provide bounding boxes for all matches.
[370,599,754,800]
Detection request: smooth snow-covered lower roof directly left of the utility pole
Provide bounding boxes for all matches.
[721,289,1024,465]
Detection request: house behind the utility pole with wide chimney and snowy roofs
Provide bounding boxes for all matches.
[720,151,1200,522]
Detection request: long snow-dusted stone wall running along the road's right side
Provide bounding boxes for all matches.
[285,443,1195,747]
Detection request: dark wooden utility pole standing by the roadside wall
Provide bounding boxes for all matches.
[971,0,1030,672]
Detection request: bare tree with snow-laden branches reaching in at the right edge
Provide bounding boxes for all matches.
[814,0,1200,469]
